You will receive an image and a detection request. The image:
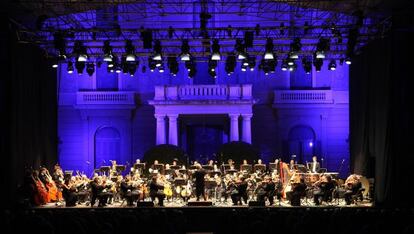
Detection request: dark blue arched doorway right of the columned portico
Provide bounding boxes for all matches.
[288,125,317,163]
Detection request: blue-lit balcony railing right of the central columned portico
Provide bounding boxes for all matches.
[274,90,333,103]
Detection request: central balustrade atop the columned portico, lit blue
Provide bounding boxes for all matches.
[154,84,252,100]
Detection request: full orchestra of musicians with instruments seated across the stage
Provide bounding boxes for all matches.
[21,156,363,207]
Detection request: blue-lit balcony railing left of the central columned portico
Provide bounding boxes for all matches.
[76,91,135,105]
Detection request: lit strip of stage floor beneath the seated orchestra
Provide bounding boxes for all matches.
[37,198,373,209]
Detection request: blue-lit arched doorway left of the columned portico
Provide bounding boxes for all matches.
[94,127,121,168]
